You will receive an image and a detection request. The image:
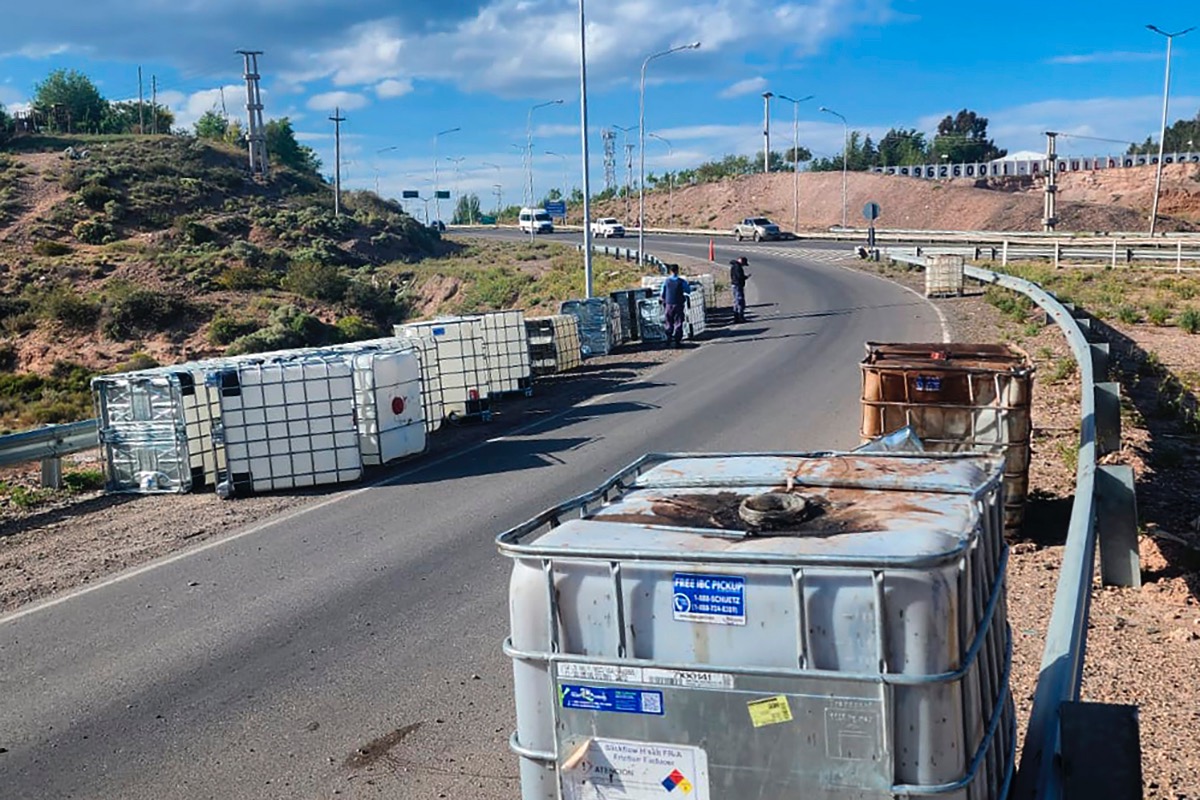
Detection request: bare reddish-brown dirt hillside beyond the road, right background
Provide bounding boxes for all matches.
[595,166,1200,231]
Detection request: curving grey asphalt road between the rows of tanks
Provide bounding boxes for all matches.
[0,237,942,800]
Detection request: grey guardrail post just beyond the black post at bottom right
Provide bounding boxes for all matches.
[1096,464,1141,589]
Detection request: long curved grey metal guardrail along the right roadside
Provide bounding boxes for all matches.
[888,253,1140,800]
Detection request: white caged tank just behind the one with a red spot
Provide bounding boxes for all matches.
[394,317,492,422]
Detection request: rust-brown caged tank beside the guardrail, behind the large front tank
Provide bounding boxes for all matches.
[862,342,1033,534]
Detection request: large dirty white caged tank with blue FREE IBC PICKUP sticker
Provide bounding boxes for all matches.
[498,453,1015,800]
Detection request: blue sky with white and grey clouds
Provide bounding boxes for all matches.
[0,0,1200,207]
